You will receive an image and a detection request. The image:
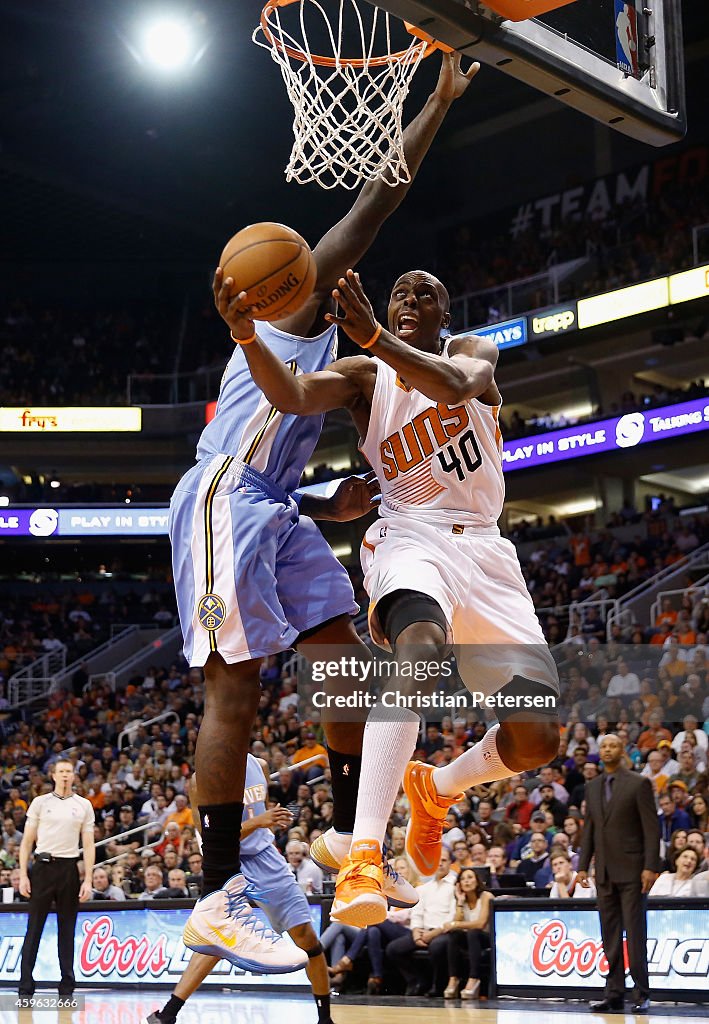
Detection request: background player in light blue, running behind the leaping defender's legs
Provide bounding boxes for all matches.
[143,754,332,1024]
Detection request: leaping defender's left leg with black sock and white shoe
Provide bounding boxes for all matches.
[183,653,305,974]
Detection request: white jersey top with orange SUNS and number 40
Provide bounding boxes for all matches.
[360,342,505,526]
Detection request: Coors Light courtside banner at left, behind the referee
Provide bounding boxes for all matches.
[0,903,322,988]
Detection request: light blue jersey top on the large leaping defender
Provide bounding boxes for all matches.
[197,323,337,494]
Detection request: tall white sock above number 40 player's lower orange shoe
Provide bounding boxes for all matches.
[352,705,420,846]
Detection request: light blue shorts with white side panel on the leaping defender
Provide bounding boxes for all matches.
[169,455,358,666]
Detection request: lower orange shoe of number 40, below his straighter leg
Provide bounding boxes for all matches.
[330,840,387,928]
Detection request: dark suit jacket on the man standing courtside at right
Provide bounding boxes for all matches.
[579,767,660,884]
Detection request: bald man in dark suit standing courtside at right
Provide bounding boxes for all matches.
[577,733,660,1013]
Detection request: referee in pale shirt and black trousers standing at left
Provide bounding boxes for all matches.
[19,759,95,997]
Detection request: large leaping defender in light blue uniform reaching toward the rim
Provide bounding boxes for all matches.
[170,54,474,973]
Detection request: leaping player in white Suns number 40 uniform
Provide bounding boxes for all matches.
[219,270,558,925]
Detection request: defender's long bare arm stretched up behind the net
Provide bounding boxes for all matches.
[281,53,479,337]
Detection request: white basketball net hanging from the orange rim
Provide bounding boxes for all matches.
[253,0,431,188]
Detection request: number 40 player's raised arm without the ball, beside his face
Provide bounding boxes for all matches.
[326,270,498,404]
